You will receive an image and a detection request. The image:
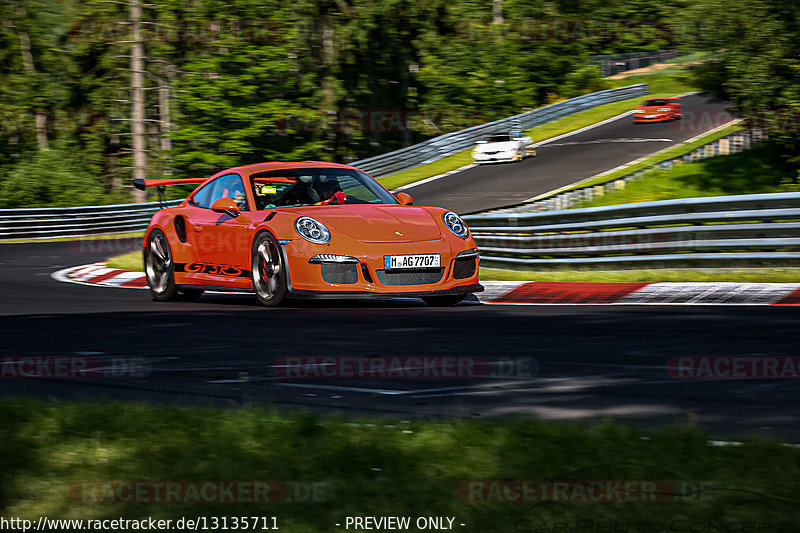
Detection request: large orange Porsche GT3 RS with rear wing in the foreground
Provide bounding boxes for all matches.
[134,161,483,306]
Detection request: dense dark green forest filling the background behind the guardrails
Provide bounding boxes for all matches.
[0,0,710,205]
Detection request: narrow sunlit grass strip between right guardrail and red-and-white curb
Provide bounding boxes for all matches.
[480,267,800,283]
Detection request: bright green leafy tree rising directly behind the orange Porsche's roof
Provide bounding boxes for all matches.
[172,0,319,175]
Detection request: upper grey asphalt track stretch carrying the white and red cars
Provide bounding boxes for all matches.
[404,95,731,214]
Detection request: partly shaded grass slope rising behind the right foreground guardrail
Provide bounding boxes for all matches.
[576,143,797,207]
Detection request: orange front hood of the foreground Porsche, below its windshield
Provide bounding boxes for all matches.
[282,204,442,242]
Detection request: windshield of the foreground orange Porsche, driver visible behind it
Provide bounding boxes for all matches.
[251,168,397,210]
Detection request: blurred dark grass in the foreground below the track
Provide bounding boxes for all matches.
[0,400,800,533]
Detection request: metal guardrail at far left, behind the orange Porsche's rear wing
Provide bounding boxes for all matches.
[0,200,181,240]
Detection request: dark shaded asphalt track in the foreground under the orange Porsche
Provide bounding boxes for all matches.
[0,241,800,441]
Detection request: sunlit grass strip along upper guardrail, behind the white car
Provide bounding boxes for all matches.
[378,69,695,190]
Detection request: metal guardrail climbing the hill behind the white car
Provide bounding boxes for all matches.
[352,84,647,178]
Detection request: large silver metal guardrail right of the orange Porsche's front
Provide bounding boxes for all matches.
[464,193,800,268]
